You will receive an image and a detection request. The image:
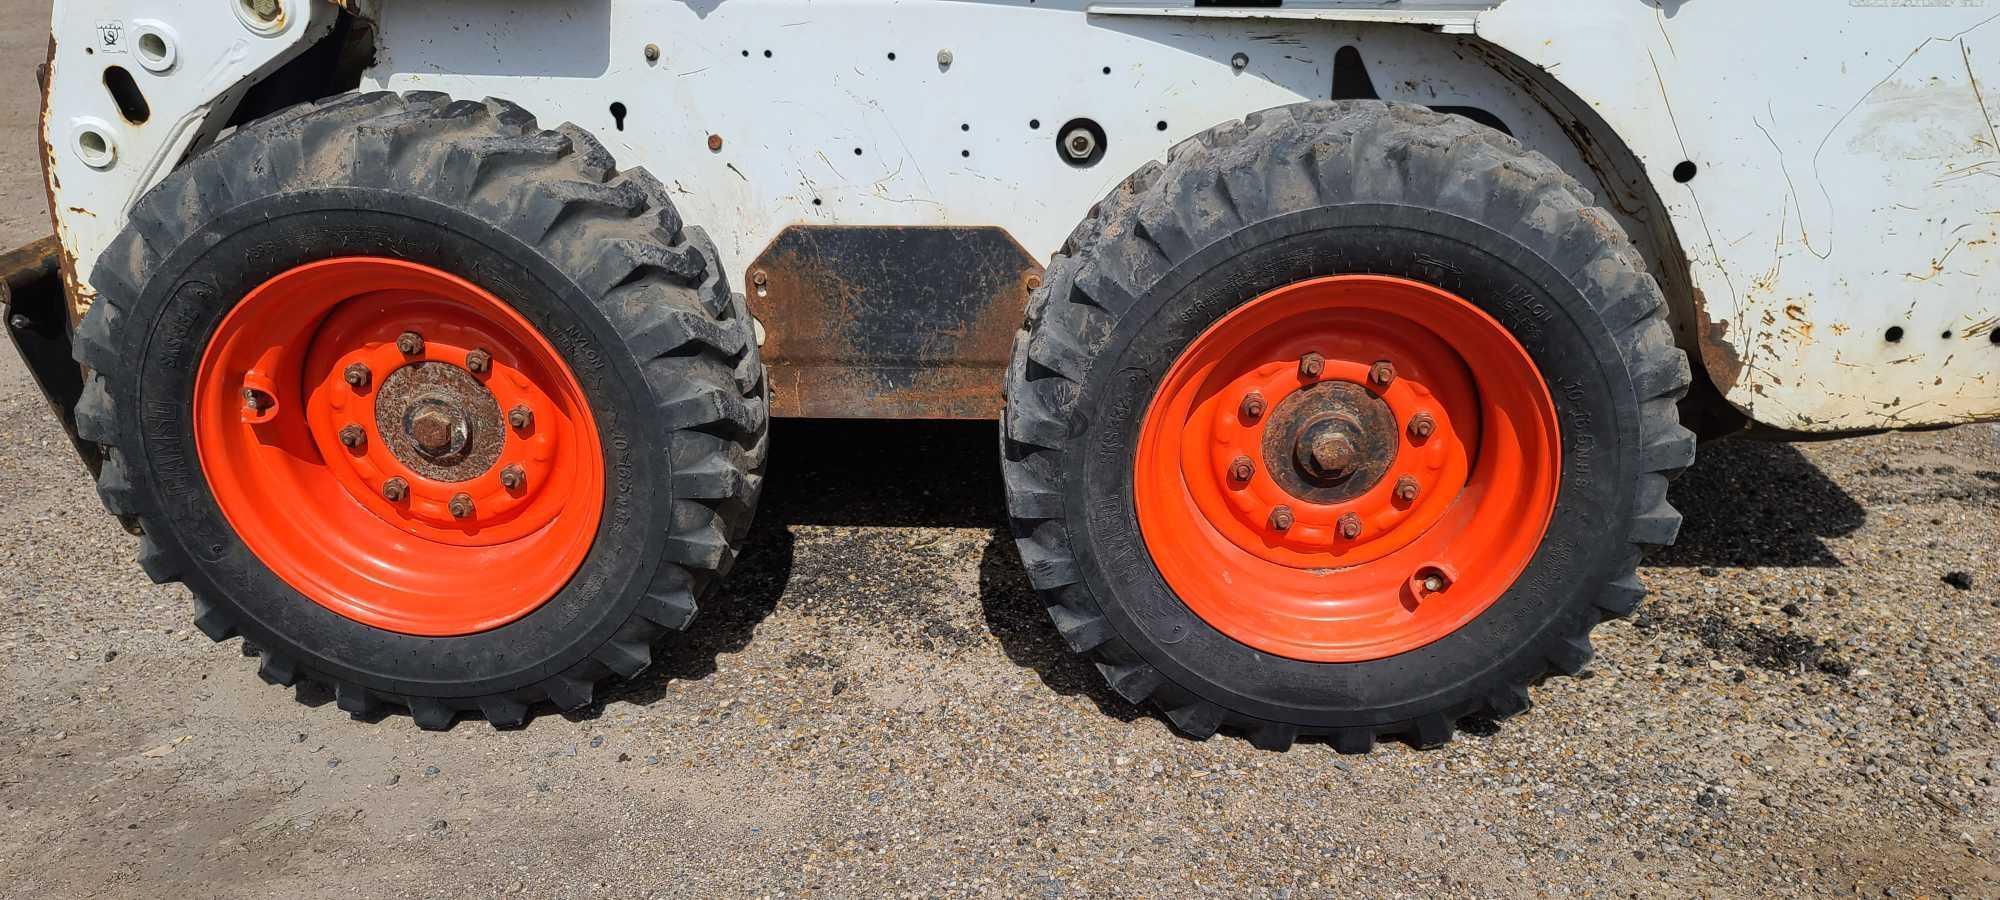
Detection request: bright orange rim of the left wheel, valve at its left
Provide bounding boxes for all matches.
[194,258,604,636]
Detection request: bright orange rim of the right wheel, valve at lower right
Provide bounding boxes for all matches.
[1134,276,1562,662]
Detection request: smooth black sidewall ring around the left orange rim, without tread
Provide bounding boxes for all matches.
[116,188,672,696]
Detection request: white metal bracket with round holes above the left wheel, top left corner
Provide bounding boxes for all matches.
[42,0,334,304]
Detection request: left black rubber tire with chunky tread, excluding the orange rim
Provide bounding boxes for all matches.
[76,92,768,728]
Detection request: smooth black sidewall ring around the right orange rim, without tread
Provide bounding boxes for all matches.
[1062,204,1640,726]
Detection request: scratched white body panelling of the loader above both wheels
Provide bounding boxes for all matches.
[50,0,2000,430]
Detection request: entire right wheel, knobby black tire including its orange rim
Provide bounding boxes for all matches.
[1002,102,1694,752]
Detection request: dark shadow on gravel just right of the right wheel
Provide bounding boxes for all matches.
[1646,440,1866,568]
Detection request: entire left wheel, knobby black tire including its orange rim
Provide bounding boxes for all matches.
[76,92,766,728]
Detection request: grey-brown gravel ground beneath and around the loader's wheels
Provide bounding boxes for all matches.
[0,0,2000,896]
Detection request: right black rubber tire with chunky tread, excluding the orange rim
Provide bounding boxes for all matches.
[1002,102,1694,752]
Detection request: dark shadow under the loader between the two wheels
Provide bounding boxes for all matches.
[592,420,1144,720]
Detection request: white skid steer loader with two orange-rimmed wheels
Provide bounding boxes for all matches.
[4,0,2000,752]
